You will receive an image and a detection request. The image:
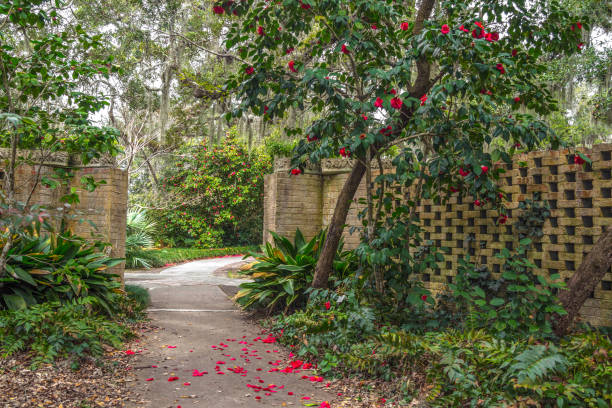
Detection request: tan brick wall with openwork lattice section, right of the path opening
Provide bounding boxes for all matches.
[264,144,612,326]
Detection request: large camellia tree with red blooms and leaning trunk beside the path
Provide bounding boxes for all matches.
[218,0,604,332]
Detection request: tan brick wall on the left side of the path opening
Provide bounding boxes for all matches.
[0,149,128,279]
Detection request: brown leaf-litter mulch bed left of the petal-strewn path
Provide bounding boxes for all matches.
[0,323,152,408]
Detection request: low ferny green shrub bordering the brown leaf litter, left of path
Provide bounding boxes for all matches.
[0,296,131,367]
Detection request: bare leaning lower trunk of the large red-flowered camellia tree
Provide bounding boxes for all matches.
[312,161,365,288]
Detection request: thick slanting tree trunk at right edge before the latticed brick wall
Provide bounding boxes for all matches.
[554,227,612,336]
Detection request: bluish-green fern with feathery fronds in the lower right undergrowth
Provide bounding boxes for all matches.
[506,345,568,384]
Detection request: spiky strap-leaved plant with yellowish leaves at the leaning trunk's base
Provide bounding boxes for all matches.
[234,229,350,312]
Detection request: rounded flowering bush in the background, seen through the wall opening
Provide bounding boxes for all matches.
[158,134,271,248]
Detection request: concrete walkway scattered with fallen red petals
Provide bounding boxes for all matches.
[125,257,333,408]
